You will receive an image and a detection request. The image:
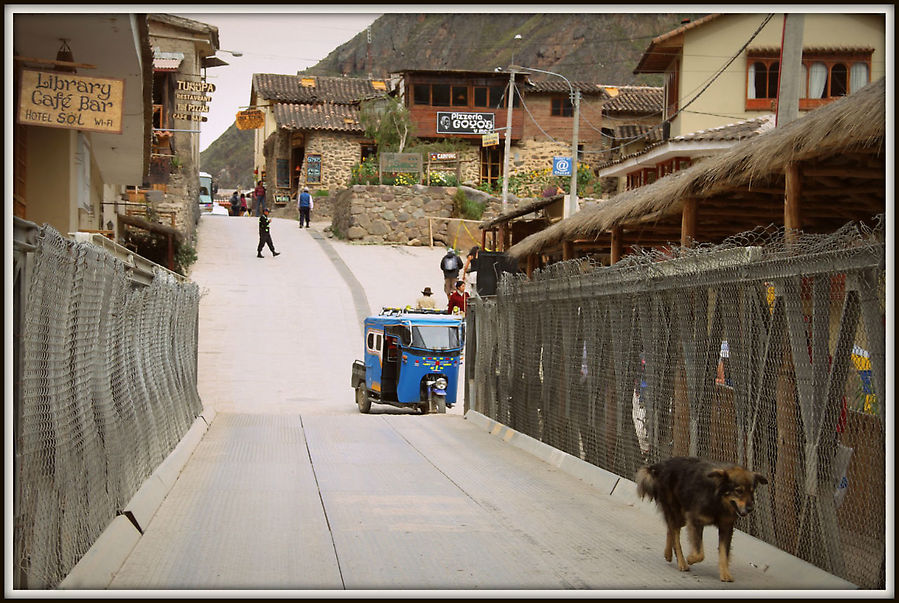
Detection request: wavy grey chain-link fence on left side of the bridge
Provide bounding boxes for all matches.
[14,226,202,588]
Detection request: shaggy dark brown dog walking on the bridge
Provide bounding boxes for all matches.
[635,456,768,582]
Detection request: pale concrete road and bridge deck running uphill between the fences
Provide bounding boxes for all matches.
[105,216,845,595]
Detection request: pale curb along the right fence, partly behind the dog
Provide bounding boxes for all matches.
[465,410,858,590]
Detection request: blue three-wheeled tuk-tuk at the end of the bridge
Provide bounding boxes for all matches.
[351,308,464,414]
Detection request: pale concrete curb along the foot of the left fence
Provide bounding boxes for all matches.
[56,407,215,590]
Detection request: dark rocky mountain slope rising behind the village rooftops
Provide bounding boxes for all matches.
[200,13,700,188]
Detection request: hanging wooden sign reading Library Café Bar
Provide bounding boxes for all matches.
[16,69,125,134]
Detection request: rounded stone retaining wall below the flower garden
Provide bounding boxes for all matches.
[330,184,502,245]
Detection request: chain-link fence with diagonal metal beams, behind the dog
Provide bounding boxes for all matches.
[466,216,886,588]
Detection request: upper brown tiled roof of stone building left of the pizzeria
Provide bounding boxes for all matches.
[253,73,385,104]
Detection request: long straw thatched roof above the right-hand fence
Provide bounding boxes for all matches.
[508,79,886,258]
